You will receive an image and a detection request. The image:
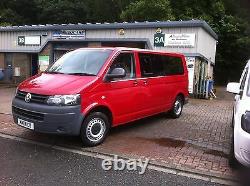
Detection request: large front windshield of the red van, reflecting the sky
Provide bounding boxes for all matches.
[46,49,112,76]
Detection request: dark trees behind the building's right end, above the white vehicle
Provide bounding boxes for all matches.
[171,0,250,84]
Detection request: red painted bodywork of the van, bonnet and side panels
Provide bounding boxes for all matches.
[19,48,188,126]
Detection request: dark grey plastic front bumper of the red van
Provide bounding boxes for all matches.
[12,98,84,136]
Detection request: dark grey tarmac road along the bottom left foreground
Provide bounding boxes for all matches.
[0,138,223,186]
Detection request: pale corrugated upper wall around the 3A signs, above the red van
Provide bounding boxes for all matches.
[86,27,216,62]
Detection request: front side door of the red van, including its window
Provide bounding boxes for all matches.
[105,52,140,125]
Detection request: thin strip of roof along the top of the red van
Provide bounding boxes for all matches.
[77,47,184,56]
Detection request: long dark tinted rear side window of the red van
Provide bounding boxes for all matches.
[139,53,184,77]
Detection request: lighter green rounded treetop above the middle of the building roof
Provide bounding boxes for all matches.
[120,0,174,21]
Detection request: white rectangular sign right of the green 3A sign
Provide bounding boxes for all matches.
[165,33,195,47]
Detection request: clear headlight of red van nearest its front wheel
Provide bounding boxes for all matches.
[47,94,80,106]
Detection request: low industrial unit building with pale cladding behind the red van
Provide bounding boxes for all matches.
[0,20,218,97]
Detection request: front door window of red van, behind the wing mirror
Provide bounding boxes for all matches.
[108,53,135,80]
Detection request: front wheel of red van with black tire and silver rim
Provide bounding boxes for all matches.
[81,112,110,147]
